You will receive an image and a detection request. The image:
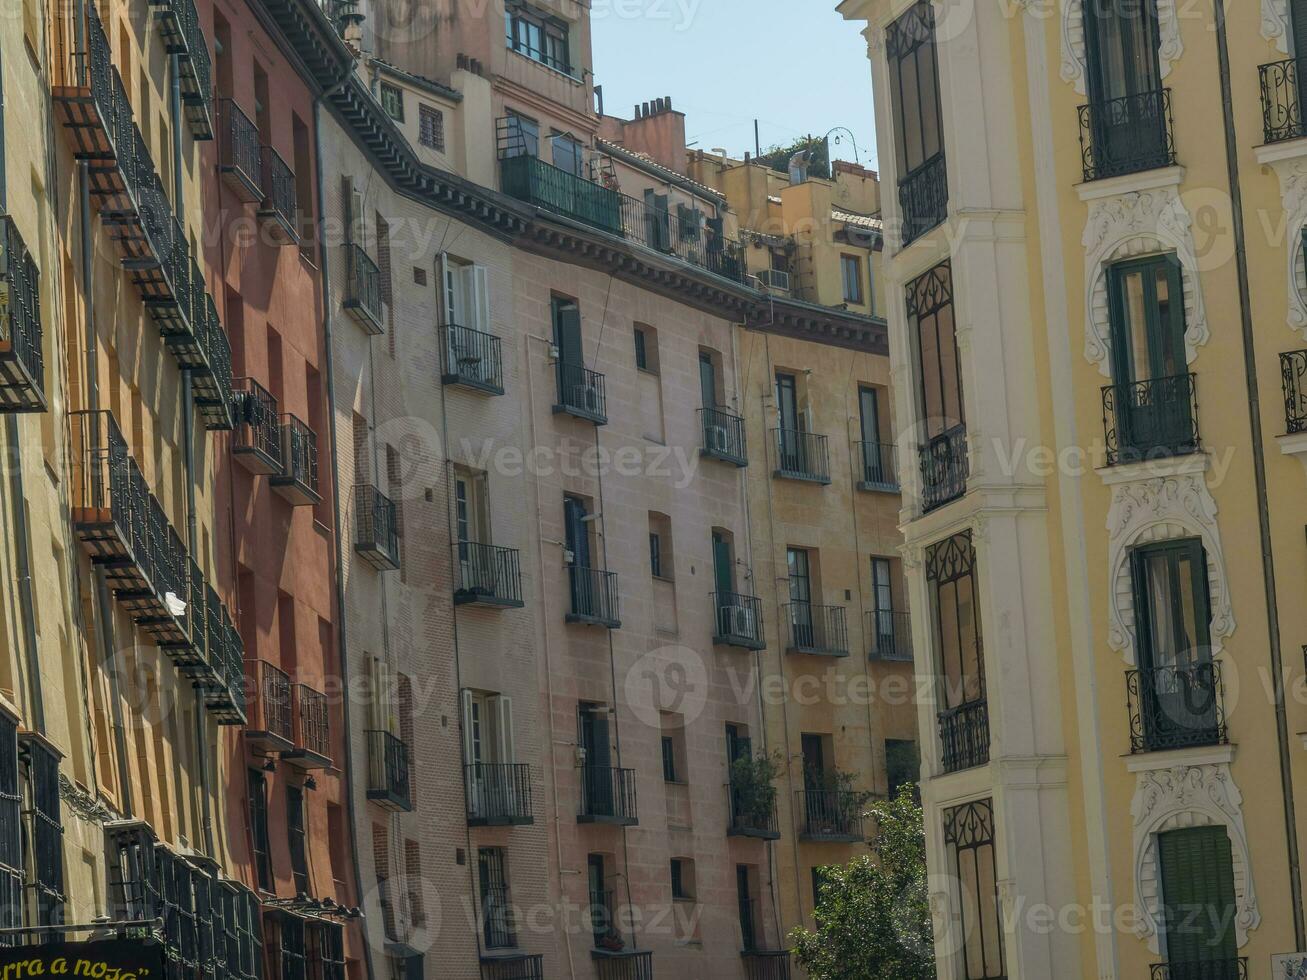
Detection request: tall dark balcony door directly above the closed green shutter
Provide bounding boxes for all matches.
[1131,540,1218,746]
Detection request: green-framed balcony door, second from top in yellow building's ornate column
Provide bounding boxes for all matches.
[1108,253,1195,462]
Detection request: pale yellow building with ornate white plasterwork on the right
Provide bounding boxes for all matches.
[840,0,1307,979]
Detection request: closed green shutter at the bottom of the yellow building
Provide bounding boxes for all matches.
[1157,827,1238,963]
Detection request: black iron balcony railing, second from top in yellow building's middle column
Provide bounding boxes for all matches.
[1103,374,1201,466]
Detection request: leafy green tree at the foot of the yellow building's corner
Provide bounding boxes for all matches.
[789,785,935,980]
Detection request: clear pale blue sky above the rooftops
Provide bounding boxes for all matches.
[591,0,876,167]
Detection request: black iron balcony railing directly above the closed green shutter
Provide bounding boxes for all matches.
[1125,661,1229,753]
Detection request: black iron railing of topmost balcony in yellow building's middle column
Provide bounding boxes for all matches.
[1080,89,1175,183]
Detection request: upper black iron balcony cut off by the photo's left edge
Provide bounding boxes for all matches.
[0,214,46,412]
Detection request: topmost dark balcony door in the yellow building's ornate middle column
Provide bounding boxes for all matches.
[1085,0,1166,176]
